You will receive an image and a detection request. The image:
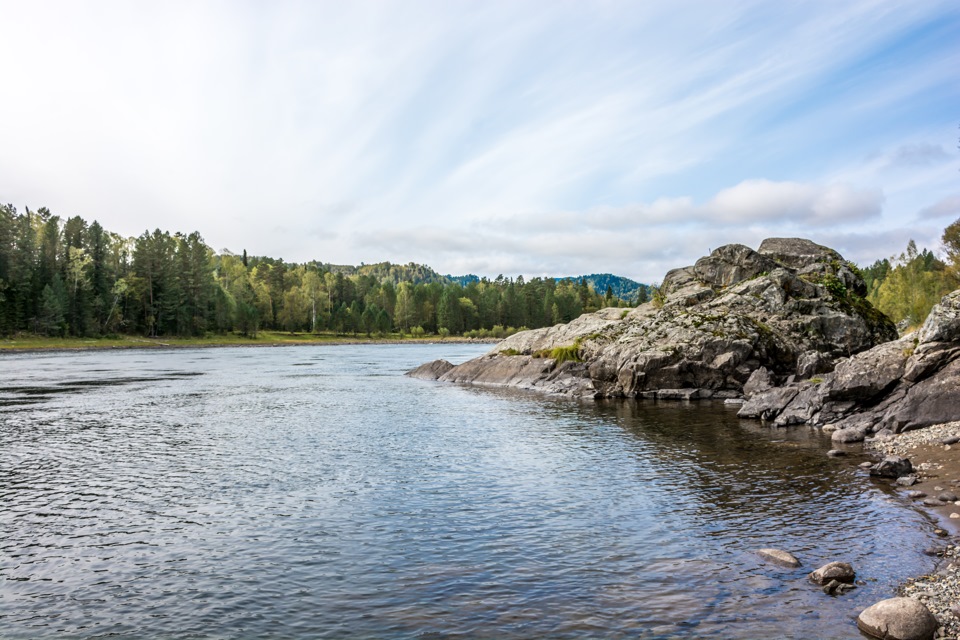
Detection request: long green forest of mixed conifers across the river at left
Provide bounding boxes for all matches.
[0,204,627,337]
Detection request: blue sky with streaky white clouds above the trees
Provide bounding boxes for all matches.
[0,0,960,283]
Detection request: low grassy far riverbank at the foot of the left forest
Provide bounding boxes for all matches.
[0,331,500,354]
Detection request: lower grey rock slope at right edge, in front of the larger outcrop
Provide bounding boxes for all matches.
[739,290,960,443]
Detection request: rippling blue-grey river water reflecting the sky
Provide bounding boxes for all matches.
[0,345,932,638]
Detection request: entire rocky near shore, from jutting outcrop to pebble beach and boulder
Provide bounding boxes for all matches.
[408,238,960,640]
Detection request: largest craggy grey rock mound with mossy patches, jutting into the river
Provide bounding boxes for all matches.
[408,238,896,400]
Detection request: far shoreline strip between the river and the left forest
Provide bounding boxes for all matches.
[0,336,502,357]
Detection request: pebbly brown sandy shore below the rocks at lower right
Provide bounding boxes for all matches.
[865,421,960,638]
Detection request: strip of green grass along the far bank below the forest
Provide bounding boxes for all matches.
[0,331,480,352]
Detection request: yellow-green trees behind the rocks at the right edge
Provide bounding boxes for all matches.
[861,219,960,330]
